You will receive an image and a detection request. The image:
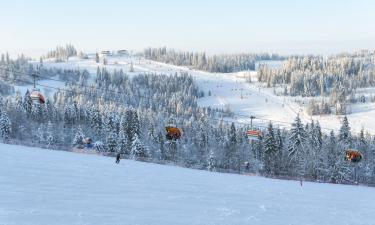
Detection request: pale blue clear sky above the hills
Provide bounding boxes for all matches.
[0,0,375,55]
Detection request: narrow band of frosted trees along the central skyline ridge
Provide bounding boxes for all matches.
[143,47,284,73]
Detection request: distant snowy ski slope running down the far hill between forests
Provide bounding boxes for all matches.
[36,55,375,134]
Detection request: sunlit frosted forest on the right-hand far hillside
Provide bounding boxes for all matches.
[258,51,375,114]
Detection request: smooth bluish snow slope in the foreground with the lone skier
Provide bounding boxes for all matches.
[0,144,375,225]
